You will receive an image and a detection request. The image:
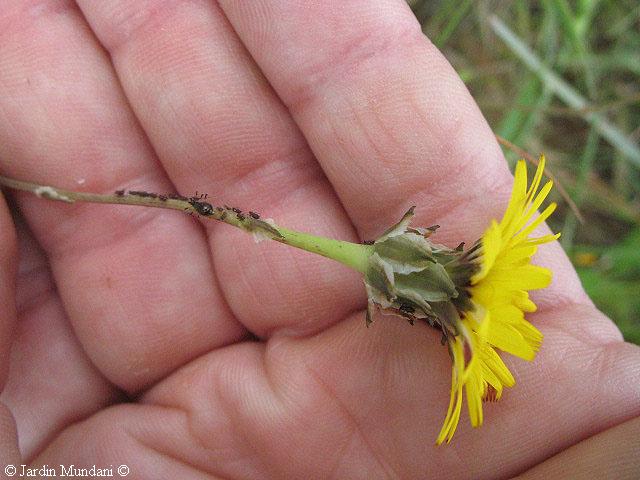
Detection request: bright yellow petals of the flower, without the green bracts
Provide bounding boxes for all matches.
[436,156,560,445]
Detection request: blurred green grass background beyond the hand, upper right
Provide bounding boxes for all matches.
[409,0,640,344]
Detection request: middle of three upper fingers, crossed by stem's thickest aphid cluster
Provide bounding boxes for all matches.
[78,0,364,336]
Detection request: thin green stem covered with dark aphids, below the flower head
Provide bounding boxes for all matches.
[0,175,373,273]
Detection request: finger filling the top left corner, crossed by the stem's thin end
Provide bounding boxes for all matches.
[0,0,244,389]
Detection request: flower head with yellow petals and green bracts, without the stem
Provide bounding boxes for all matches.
[365,157,560,444]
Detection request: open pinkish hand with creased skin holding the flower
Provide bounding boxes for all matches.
[0,0,640,480]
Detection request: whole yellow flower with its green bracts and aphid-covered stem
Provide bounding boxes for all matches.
[0,157,560,444]
